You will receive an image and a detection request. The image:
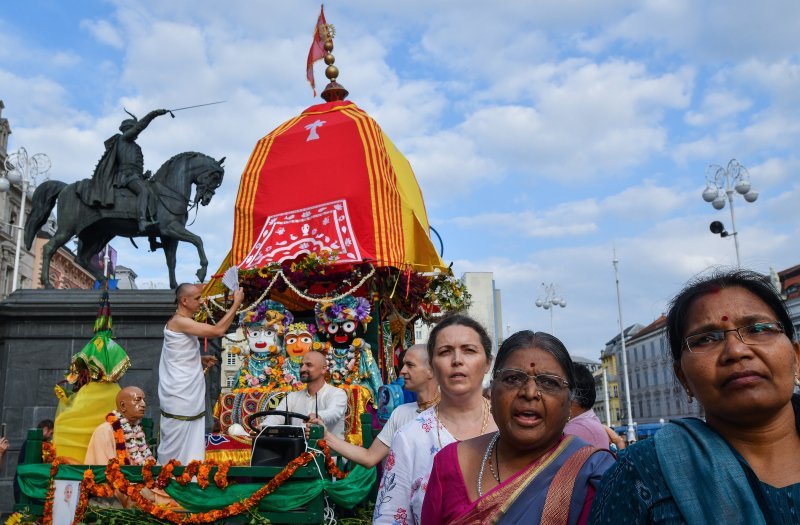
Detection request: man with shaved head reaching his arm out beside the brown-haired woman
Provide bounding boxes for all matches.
[310,345,439,468]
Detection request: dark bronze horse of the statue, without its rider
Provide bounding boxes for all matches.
[25,152,225,288]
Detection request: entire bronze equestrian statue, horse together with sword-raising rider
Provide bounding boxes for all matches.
[25,109,225,288]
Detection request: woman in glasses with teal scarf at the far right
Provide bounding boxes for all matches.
[590,270,800,524]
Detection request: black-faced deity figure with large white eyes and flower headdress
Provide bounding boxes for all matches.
[314,296,383,403]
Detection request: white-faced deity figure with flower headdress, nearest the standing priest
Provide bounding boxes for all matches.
[236,299,294,389]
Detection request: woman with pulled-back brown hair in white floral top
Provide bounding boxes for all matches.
[373,314,497,525]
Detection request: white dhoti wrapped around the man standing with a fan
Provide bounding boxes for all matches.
[158,327,206,465]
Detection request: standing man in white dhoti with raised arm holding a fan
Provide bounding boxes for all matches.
[158,283,244,465]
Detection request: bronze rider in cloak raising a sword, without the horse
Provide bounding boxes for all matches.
[80,109,168,233]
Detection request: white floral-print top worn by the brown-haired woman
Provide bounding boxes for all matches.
[372,407,456,525]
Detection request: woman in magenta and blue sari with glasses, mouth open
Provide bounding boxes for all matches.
[422,330,614,525]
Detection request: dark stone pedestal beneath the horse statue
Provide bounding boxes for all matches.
[0,290,219,515]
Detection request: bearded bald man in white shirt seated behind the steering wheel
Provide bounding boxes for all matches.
[261,350,347,439]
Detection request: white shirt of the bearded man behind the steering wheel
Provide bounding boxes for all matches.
[261,383,347,439]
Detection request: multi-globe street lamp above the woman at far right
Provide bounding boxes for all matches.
[703,159,758,267]
